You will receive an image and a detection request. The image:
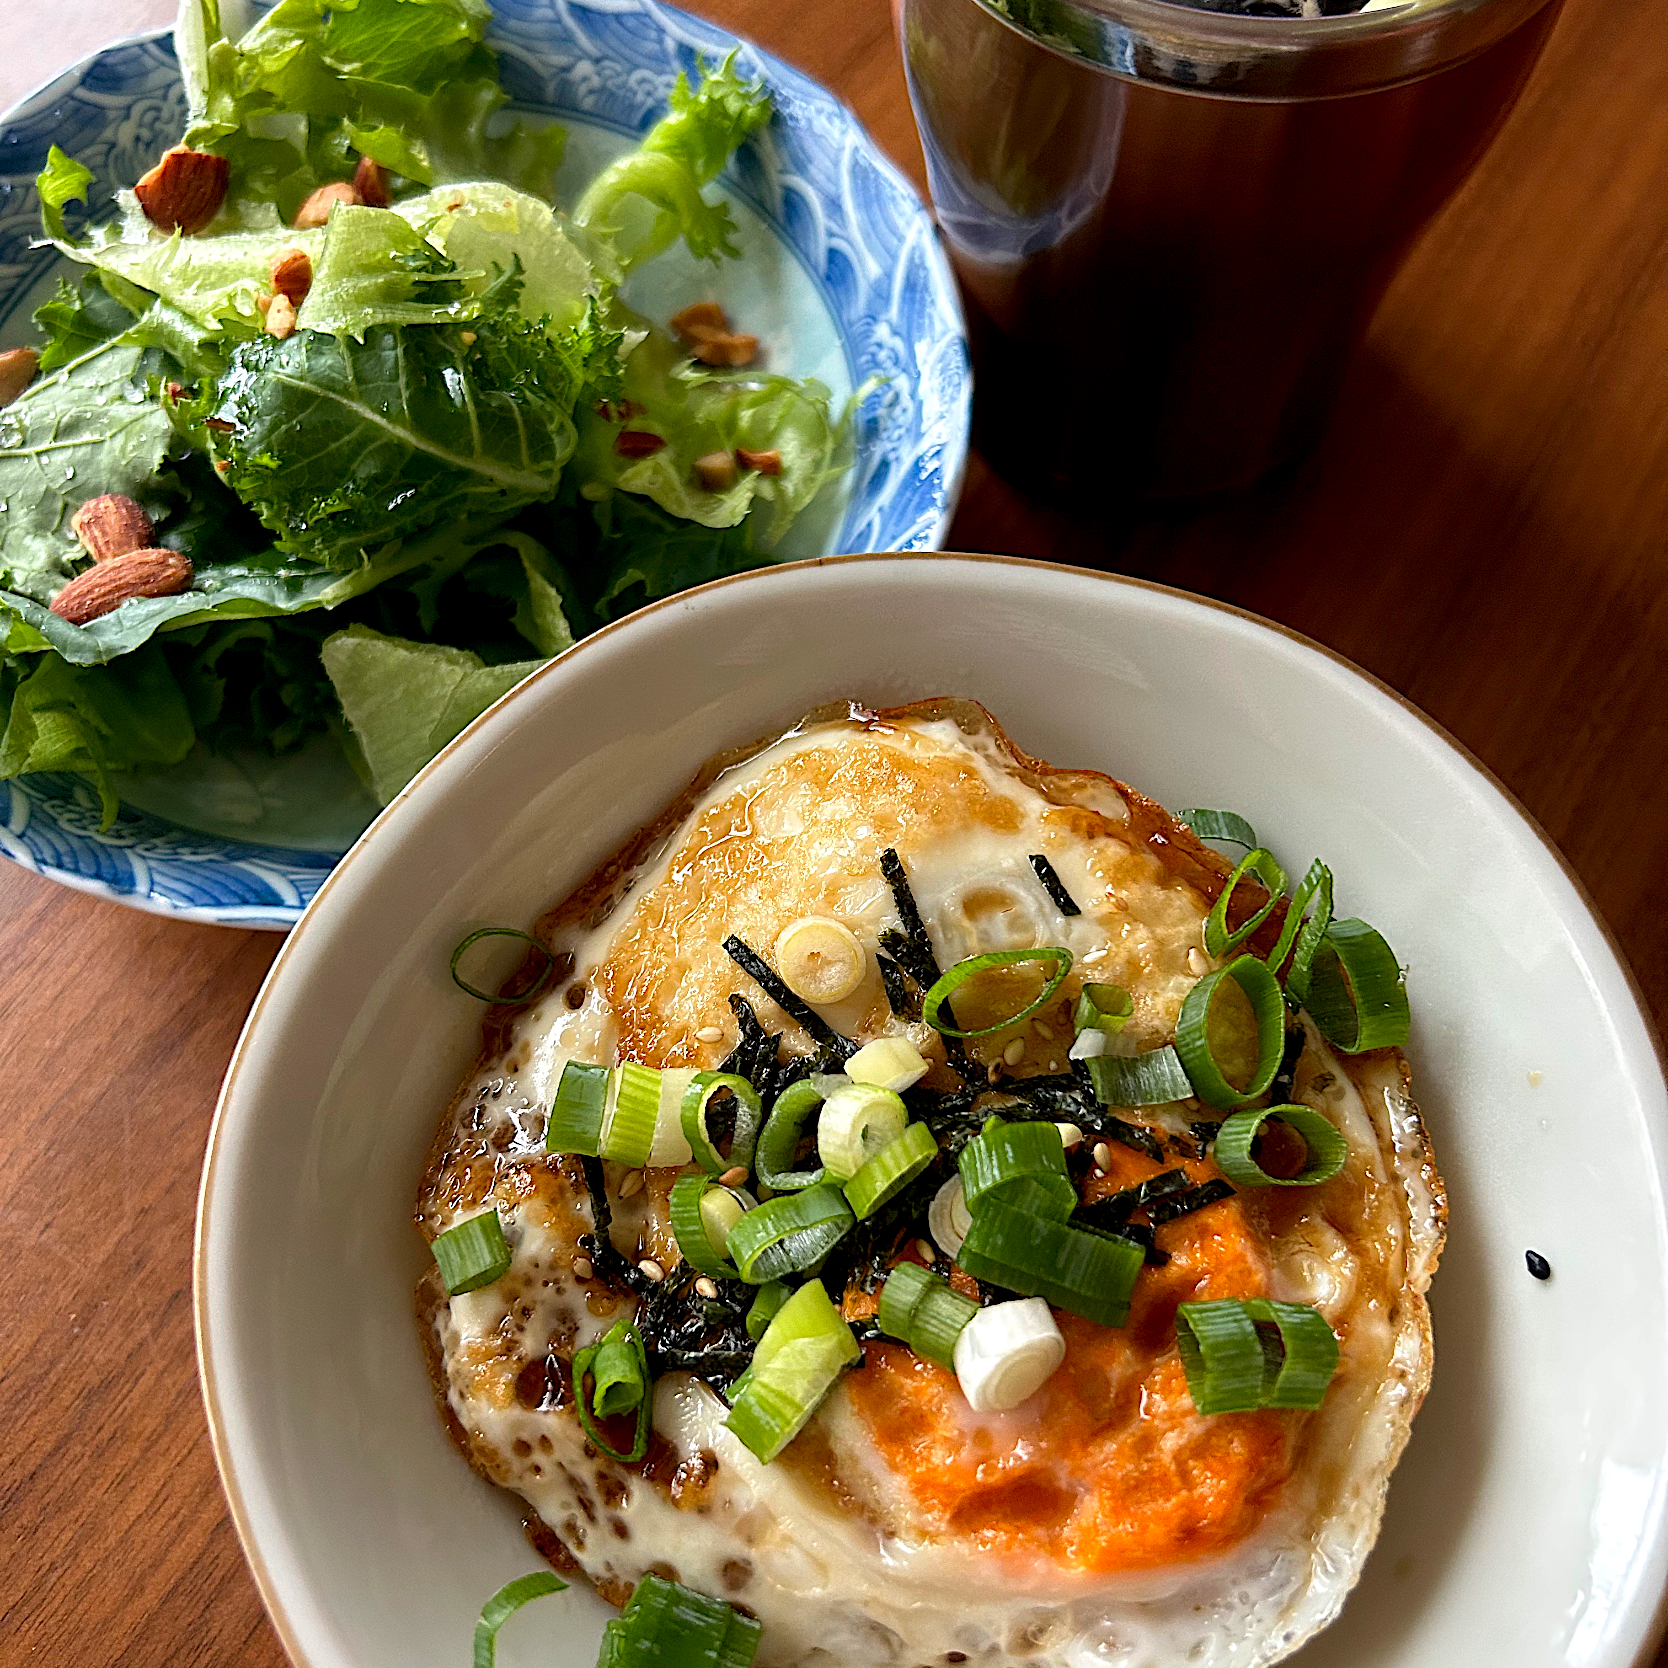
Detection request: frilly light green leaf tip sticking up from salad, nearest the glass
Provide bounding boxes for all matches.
[574,53,771,272]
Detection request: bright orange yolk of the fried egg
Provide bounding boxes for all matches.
[847,1148,1293,1573]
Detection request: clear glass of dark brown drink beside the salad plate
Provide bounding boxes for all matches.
[896,0,1561,497]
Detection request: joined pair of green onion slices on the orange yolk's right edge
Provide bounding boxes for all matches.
[1176,1298,1338,1413]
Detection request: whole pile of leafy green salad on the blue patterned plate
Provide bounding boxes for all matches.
[0,0,851,819]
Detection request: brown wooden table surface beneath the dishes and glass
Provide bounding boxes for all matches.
[0,0,1668,1668]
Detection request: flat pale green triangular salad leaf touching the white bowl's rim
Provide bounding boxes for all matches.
[324,626,544,804]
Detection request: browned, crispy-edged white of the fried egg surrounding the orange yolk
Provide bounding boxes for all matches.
[419,707,1444,1668]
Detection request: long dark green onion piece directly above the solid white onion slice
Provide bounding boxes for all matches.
[956,1201,1146,1326]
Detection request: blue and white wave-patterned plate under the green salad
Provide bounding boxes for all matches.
[0,0,972,931]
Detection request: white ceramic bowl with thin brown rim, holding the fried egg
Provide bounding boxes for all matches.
[197,557,1668,1668]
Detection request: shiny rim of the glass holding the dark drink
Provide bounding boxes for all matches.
[971,0,1563,102]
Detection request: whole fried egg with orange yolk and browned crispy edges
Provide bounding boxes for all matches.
[417,702,1444,1668]
